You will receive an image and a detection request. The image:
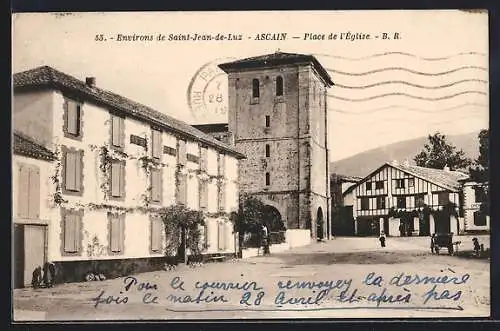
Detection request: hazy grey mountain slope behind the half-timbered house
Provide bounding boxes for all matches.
[330,132,479,177]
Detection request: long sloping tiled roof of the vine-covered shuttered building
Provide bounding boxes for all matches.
[13,66,245,158]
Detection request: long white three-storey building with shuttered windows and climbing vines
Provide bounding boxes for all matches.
[13,67,244,288]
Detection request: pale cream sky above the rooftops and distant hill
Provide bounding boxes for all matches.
[12,10,489,161]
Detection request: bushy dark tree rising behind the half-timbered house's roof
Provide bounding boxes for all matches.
[413,132,472,170]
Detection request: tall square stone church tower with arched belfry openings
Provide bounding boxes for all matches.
[219,52,333,239]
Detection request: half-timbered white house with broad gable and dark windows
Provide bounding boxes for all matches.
[352,162,468,236]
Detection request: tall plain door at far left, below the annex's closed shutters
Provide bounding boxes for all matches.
[24,224,46,286]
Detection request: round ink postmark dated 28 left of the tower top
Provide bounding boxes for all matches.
[187,58,235,122]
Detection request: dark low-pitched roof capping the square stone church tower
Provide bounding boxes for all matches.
[219,52,334,86]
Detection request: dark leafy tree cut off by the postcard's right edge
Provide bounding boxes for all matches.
[469,130,490,215]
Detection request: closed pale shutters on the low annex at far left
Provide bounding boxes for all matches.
[17,164,40,219]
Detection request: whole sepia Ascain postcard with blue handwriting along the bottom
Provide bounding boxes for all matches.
[12,10,490,322]
